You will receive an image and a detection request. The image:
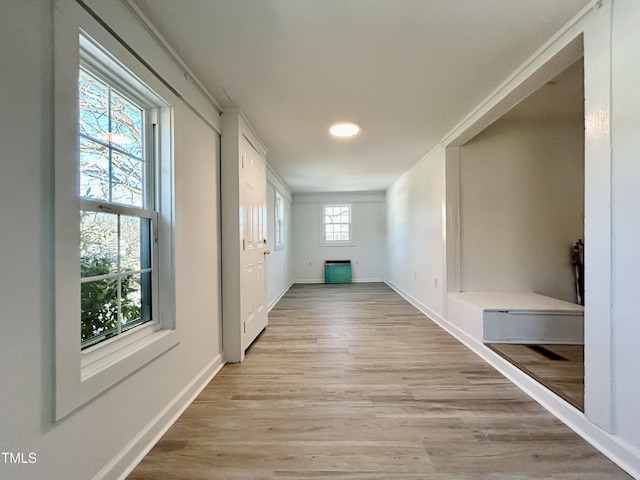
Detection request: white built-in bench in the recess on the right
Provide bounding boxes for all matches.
[447,292,584,345]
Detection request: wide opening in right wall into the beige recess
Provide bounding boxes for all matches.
[449,58,589,409]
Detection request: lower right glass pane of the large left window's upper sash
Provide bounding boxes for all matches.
[111,151,145,208]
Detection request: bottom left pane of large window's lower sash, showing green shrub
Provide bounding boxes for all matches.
[80,279,118,348]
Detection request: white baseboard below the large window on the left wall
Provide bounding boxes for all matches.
[93,355,224,480]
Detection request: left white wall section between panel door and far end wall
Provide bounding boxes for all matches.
[267,168,293,310]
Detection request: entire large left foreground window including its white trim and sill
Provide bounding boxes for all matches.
[54,26,179,419]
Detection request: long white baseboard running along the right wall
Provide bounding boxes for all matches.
[385,280,640,479]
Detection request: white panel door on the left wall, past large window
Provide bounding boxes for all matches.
[240,136,269,350]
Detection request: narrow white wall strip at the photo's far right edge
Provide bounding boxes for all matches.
[611,0,640,450]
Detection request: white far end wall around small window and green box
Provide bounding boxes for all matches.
[292,192,386,283]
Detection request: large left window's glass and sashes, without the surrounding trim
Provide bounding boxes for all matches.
[78,63,157,349]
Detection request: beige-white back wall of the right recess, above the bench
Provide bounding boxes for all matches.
[459,107,584,302]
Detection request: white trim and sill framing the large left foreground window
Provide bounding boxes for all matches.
[54,5,179,420]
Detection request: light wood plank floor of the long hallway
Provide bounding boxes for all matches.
[129,284,631,480]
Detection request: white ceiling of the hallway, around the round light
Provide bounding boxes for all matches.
[135,0,589,192]
